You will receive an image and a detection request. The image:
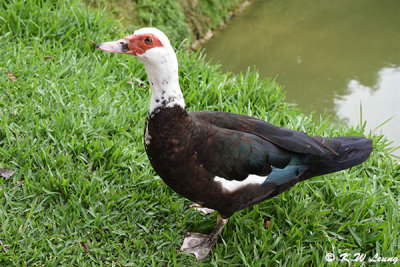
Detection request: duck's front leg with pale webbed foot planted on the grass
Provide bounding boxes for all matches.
[181,215,228,260]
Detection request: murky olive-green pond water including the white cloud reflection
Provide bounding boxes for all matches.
[204,0,400,155]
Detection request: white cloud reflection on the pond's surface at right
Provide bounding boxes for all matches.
[335,67,400,151]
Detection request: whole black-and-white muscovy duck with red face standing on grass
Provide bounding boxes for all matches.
[97,28,373,259]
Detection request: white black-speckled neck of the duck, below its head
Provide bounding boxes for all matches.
[141,49,185,114]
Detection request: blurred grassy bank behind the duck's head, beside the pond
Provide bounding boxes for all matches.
[85,0,244,45]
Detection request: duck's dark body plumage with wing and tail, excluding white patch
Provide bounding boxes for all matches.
[146,106,372,218]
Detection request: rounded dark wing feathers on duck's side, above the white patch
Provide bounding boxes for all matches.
[196,127,291,181]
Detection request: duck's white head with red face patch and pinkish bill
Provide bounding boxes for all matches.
[96,28,175,65]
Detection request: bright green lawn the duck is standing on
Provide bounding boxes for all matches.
[0,0,400,266]
